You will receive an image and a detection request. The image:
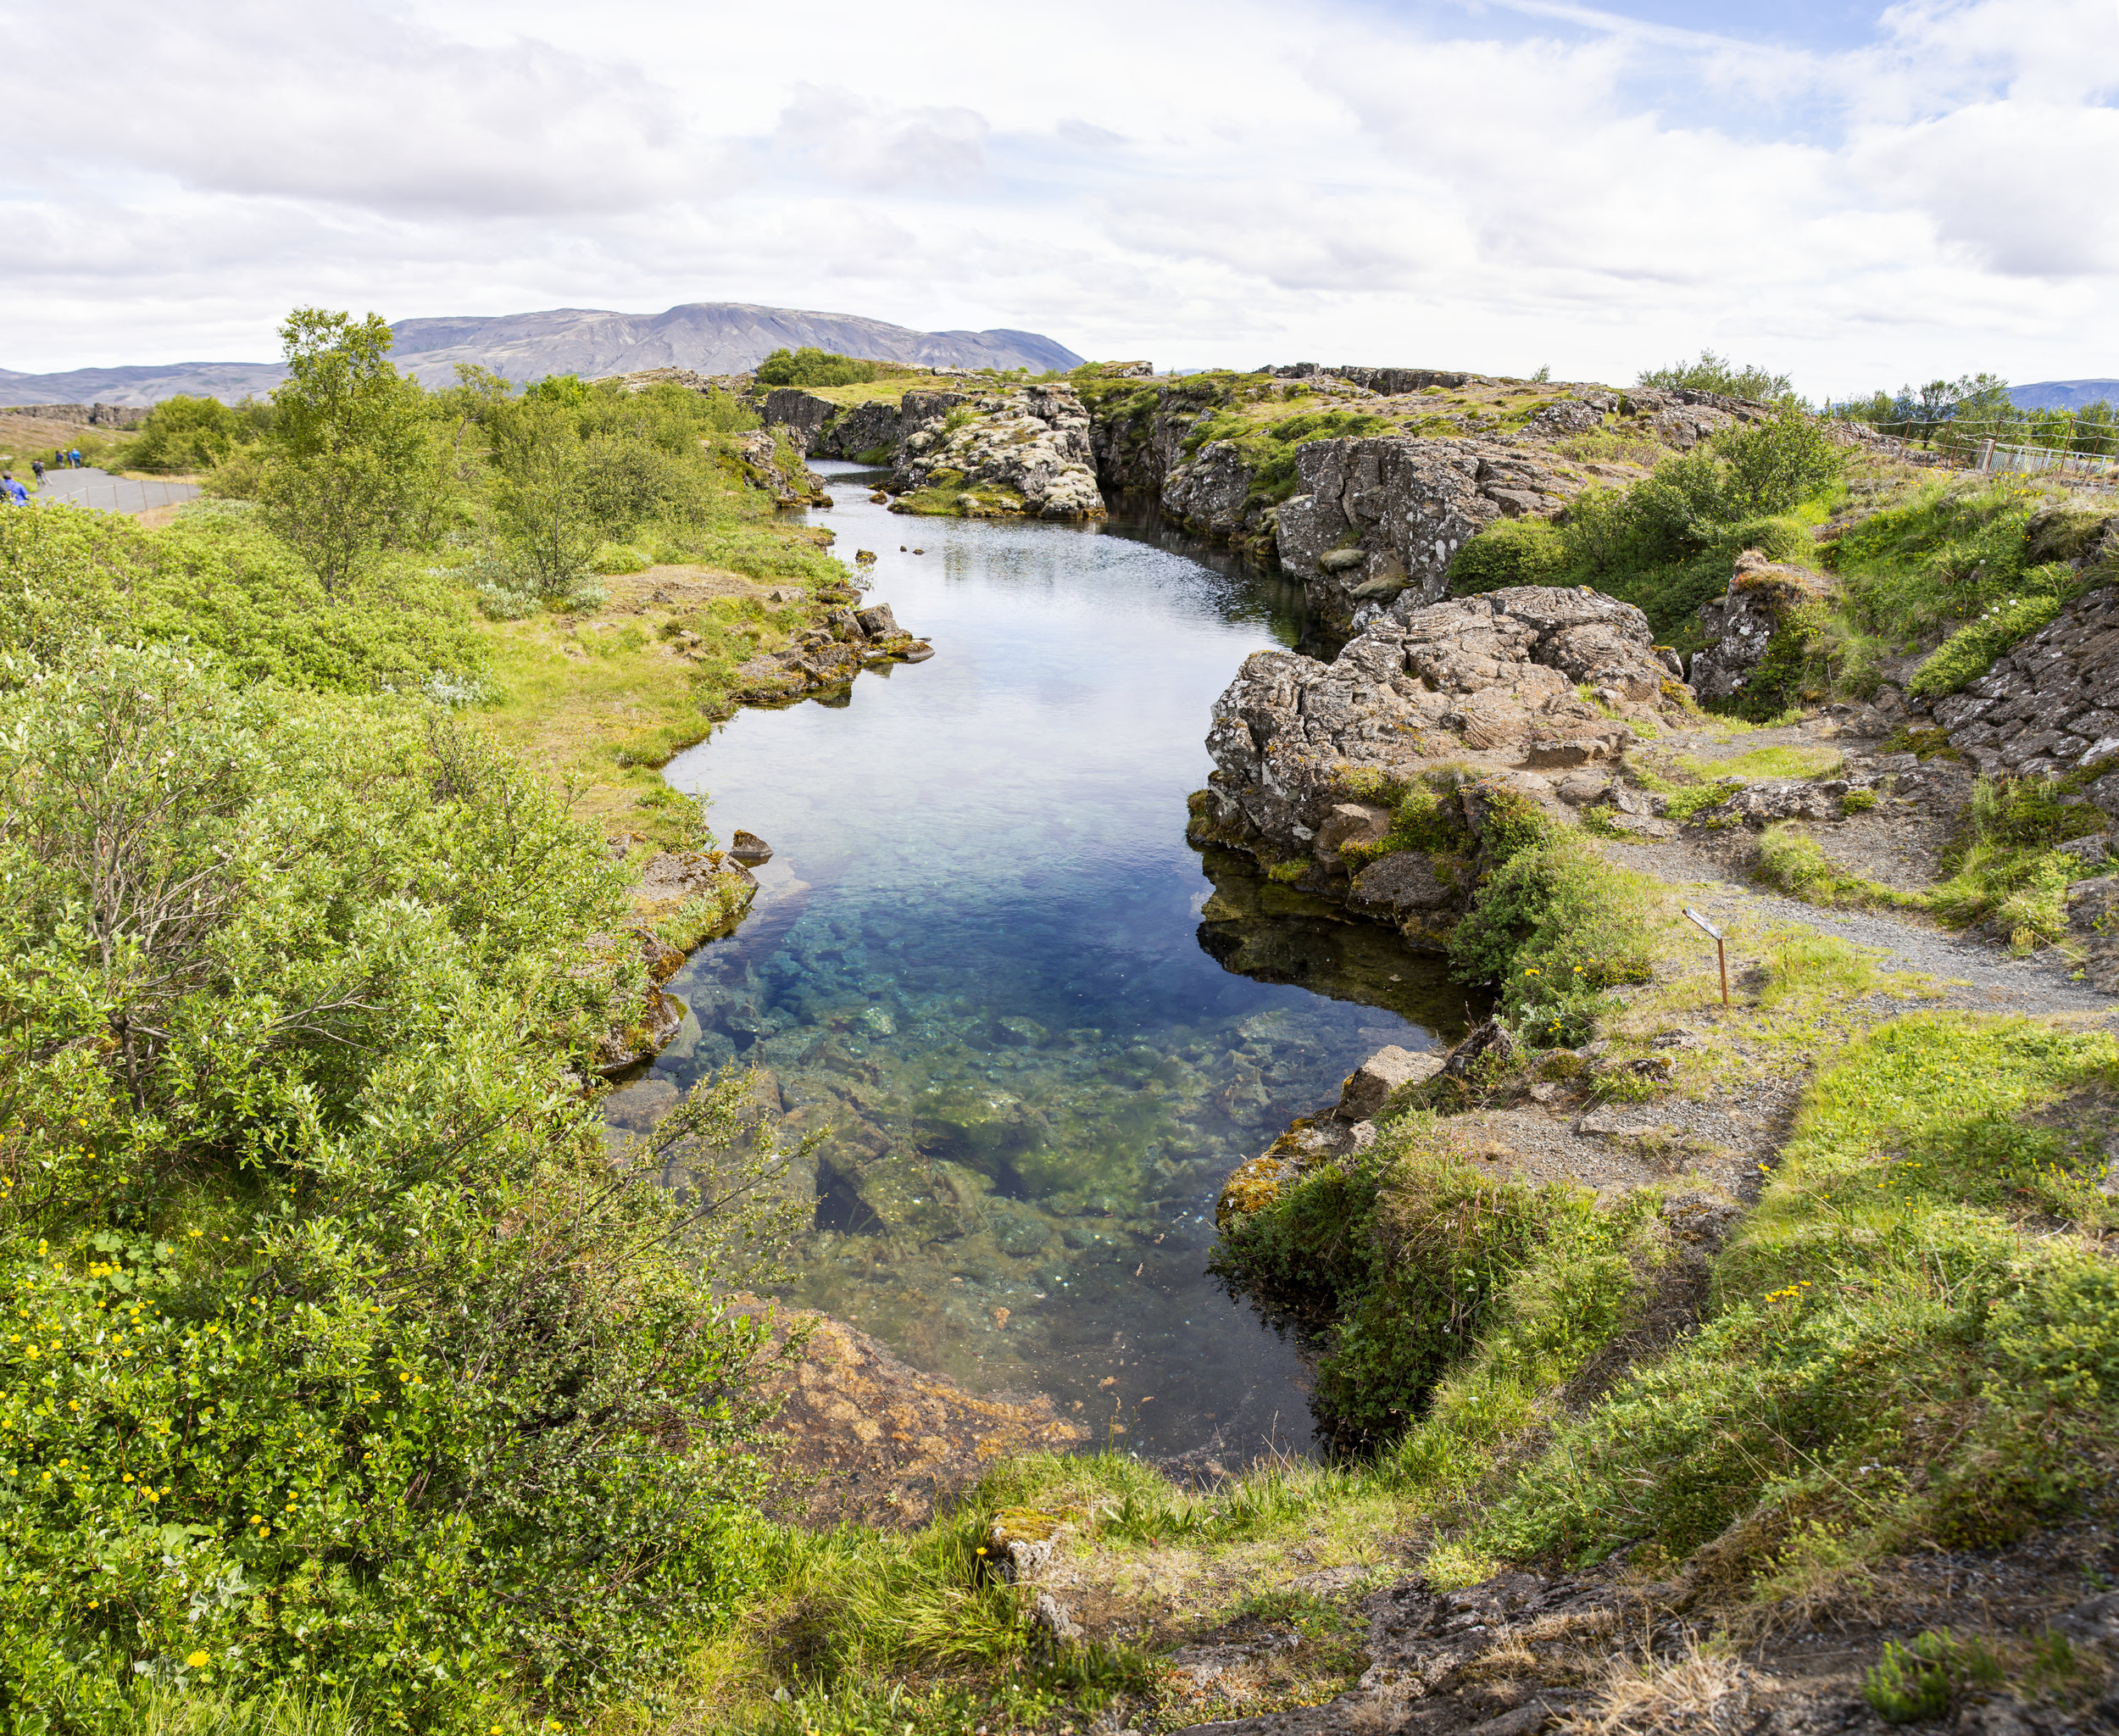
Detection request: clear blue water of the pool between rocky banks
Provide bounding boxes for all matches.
[613,465,1460,1462]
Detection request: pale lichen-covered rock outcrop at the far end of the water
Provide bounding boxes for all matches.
[890,386,1104,520]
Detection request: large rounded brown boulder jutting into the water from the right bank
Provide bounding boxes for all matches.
[1206,585,1691,869]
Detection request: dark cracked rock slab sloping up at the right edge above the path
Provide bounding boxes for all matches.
[1935,559,2119,776]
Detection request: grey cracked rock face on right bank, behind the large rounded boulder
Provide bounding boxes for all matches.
[1276,435,1581,627]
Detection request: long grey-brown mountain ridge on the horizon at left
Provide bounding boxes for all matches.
[0,301,1083,405]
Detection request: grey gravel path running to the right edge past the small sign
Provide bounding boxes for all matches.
[1610,839,2119,1013]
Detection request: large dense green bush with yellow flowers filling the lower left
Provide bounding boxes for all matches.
[0,647,797,1729]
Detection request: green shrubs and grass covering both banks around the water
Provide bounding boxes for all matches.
[0,322,2119,1736]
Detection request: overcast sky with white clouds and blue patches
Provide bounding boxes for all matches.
[0,0,2119,394]
